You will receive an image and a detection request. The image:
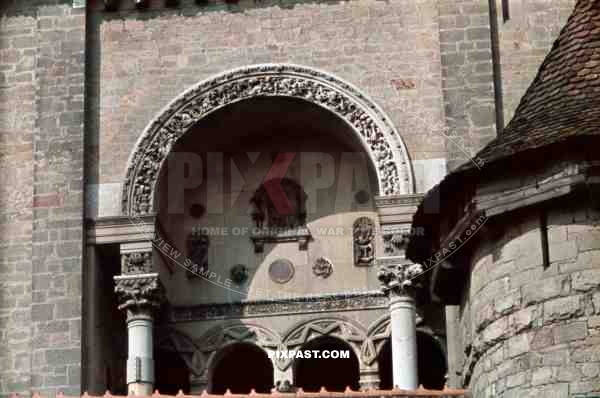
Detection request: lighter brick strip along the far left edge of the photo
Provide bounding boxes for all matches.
[0,7,36,394]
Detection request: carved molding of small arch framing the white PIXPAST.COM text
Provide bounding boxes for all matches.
[276,317,367,370]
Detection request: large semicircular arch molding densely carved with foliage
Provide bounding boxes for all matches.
[122,64,414,215]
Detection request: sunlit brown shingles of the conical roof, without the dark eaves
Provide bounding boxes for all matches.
[459,0,600,170]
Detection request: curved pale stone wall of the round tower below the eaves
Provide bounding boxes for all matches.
[461,204,600,398]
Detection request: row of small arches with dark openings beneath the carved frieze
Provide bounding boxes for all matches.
[155,316,447,394]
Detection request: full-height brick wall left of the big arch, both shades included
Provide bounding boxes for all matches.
[0,0,85,395]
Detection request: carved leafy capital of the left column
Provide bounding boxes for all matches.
[114,273,165,320]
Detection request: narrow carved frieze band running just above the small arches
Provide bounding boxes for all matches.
[171,291,389,322]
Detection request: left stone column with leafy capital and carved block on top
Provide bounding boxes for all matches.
[115,247,164,396]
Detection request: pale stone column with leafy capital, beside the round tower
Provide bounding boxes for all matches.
[378,260,423,390]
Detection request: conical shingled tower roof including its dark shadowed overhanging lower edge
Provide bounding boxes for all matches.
[407,0,600,261]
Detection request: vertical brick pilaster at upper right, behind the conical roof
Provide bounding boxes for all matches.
[439,0,496,169]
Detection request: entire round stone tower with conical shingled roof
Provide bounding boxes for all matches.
[407,0,600,398]
